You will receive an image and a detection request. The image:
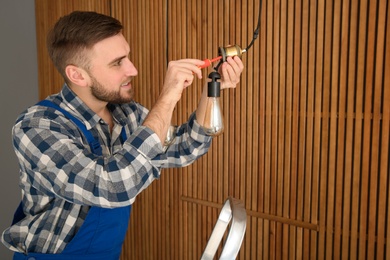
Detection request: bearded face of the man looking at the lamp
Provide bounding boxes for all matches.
[88,34,138,104]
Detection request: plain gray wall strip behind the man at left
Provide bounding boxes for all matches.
[0,0,38,260]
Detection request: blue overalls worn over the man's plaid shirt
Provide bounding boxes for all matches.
[13,100,131,260]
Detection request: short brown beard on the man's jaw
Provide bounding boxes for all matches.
[89,75,134,104]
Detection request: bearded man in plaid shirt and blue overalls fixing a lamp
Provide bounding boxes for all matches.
[2,12,243,259]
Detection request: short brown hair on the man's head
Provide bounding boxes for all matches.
[47,11,123,82]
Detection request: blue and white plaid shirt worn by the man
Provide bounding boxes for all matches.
[2,85,211,253]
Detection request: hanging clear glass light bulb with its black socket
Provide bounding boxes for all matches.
[203,72,223,136]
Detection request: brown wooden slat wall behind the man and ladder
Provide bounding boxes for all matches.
[36,0,390,259]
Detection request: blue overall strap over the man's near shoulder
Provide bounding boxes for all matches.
[37,99,102,155]
